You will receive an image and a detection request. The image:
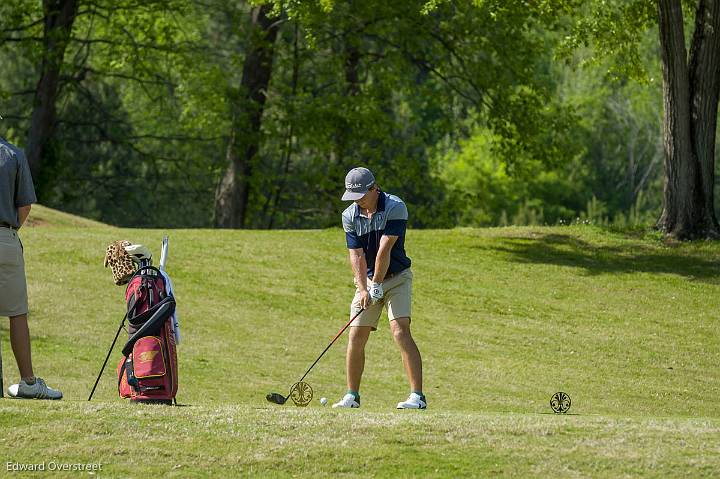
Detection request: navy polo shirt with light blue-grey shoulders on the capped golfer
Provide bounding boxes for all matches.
[342,191,410,278]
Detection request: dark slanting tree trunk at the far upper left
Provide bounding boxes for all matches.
[26,0,78,193]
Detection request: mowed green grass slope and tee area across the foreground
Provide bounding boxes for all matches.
[0,207,720,477]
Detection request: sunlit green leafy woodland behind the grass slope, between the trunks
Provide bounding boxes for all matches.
[0,0,676,228]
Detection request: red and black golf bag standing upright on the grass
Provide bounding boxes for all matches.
[117,266,178,404]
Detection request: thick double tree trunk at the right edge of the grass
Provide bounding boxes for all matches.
[658,0,720,239]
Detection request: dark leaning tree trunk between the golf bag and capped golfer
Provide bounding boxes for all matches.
[215,4,279,228]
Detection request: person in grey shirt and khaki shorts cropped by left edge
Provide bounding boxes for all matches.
[0,137,62,399]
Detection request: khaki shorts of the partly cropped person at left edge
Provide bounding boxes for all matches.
[0,227,28,316]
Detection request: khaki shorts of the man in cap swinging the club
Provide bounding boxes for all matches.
[350,268,412,331]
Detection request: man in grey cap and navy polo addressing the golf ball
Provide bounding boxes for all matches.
[333,168,427,409]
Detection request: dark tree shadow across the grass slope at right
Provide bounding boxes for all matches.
[472,233,720,284]
